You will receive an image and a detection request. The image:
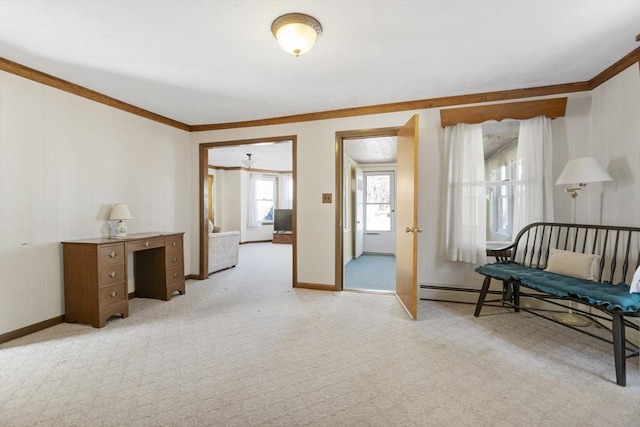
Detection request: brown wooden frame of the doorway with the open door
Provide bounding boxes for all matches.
[334,126,402,291]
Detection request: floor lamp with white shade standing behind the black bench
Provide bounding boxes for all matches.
[553,157,613,326]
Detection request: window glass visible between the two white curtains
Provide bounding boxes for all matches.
[483,122,518,242]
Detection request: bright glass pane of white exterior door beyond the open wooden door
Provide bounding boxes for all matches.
[364,172,393,232]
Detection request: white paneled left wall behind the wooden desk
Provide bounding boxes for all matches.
[0,72,190,333]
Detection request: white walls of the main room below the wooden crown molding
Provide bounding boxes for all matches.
[0,64,640,333]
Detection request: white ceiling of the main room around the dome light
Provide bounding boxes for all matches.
[0,0,640,125]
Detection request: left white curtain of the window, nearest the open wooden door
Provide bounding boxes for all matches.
[444,123,487,264]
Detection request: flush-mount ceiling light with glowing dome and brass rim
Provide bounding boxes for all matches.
[271,13,322,56]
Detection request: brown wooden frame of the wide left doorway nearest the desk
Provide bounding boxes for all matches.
[196,135,298,280]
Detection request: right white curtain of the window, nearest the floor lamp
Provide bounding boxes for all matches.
[513,116,553,237]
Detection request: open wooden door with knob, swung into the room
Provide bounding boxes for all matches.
[396,115,422,319]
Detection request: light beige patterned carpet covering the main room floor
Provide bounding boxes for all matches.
[0,244,640,427]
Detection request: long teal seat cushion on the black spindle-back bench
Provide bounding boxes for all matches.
[476,262,640,313]
